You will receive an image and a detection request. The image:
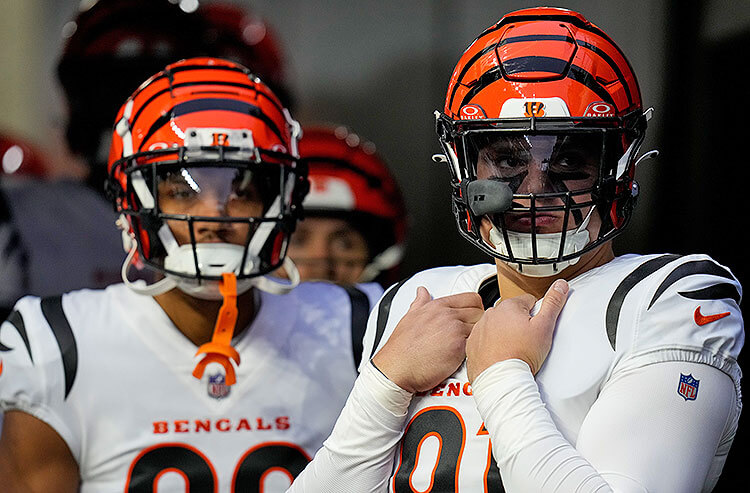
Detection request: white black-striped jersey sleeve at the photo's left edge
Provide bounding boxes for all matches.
[0,296,81,453]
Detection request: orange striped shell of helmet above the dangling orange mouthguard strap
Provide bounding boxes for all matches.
[109,58,295,187]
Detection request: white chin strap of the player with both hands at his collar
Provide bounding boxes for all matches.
[490,206,596,277]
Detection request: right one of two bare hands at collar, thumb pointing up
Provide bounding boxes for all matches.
[466,279,568,382]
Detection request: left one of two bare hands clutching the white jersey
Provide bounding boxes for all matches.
[372,286,484,393]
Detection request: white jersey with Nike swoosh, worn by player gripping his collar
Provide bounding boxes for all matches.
[361,255,744,492]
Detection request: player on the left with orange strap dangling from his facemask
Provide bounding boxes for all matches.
[0,58,382,493]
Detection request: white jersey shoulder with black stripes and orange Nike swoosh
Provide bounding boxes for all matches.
[616,255,744,376]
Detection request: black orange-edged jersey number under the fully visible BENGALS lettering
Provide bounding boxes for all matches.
[125,442,310,493]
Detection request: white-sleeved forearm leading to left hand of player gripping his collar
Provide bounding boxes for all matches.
[288,363,412,493]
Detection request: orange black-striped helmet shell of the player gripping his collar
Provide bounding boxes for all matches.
[445,7,642,120]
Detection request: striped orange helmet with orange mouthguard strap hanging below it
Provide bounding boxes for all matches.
[108,58,308,299]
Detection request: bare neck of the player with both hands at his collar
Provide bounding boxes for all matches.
[495,242,615,299]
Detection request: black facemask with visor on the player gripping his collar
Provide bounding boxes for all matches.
[436,109,645,277]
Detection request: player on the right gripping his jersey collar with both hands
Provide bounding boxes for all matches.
[293,8,744,492]
